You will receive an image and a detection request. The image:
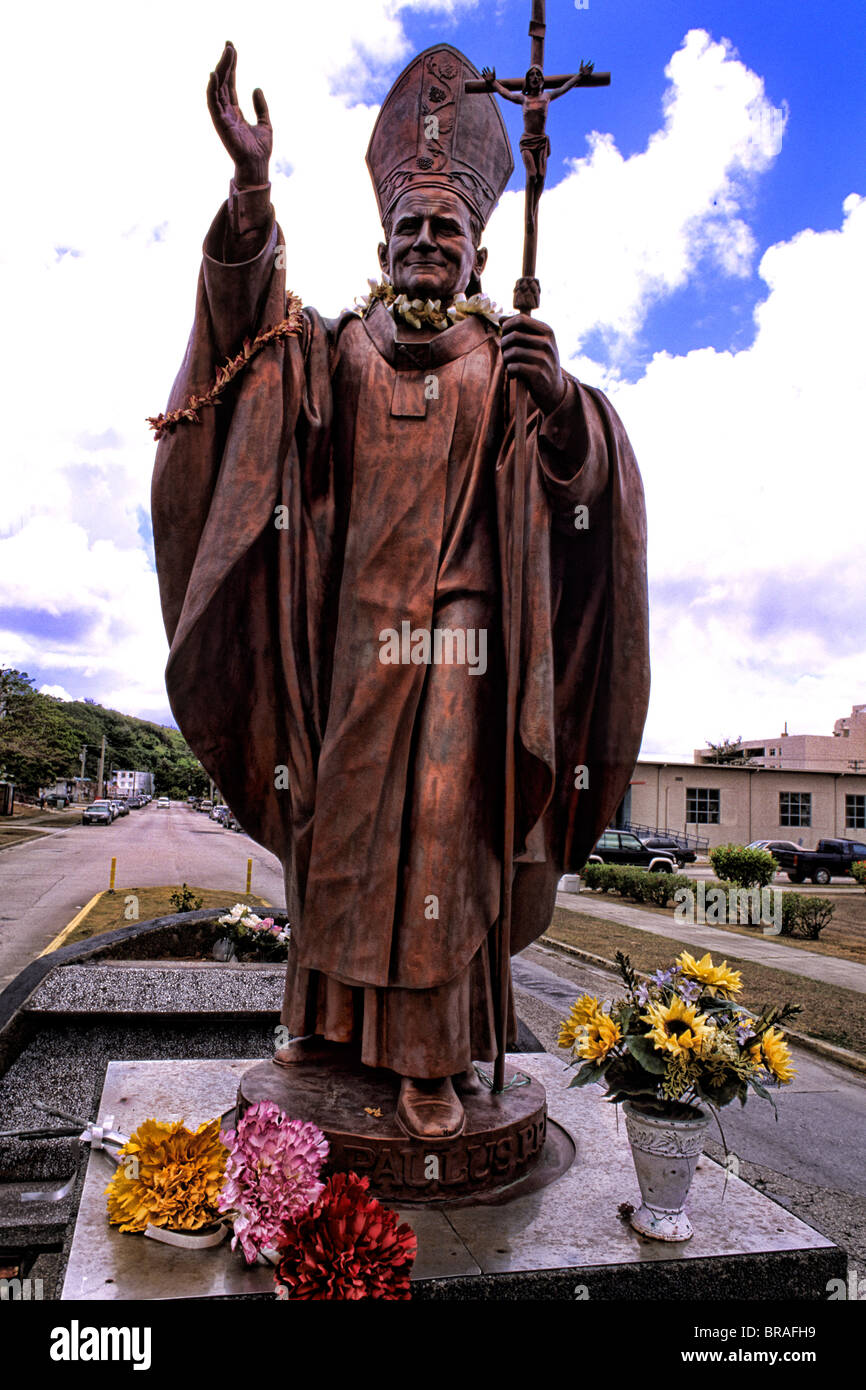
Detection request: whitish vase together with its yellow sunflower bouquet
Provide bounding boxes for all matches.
[559,951,799,1240]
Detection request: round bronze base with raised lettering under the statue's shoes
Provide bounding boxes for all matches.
[238,1054,574,1207]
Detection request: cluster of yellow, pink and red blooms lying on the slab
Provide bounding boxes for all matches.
[106,1101,417,1300]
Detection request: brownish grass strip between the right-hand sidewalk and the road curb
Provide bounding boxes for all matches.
[548,899,866,1055]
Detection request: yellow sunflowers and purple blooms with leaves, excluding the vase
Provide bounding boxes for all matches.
[559,951,801,1106]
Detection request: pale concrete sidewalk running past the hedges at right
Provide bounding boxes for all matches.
[556,892,866,994]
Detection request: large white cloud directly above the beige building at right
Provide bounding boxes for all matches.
[610,195,866,753]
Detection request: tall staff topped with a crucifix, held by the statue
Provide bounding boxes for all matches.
[466,0,610,1091]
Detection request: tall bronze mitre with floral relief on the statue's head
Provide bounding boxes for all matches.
[367,43,514,225]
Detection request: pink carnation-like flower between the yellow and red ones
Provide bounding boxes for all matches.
[218,1101,328,1265]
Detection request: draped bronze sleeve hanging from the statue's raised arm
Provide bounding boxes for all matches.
[152,207,329,878]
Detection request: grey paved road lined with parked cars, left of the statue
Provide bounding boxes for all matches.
[0,802,285,990]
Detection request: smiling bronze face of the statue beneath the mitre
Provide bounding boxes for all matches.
[379,188,487,299]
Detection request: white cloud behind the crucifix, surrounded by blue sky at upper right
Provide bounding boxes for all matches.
[485,29,785,357]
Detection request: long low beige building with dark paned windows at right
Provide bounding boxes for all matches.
[625,756,866,849]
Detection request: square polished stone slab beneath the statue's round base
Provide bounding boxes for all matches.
[63,1054,847,1301]
